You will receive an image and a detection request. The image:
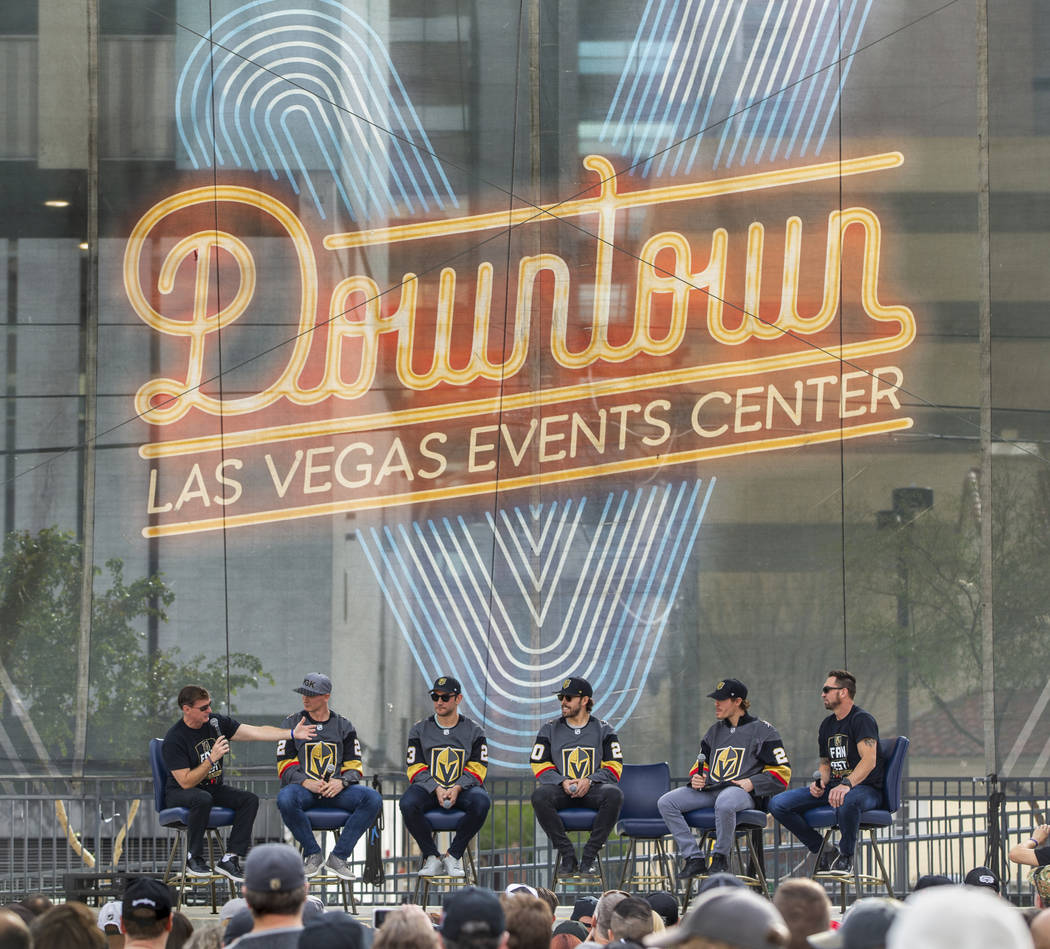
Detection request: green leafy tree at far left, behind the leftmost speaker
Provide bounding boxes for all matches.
[0,528,273,767]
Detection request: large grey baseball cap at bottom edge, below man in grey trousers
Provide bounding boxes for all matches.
[642,887,790,949]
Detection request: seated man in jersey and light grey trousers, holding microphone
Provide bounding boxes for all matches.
[656,679,791,878]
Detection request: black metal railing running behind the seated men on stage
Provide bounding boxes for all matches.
[0,773,1050,905]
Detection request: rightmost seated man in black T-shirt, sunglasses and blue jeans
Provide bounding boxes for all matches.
[770,669,885,877]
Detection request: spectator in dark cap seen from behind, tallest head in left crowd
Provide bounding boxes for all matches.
[229,844,307,949]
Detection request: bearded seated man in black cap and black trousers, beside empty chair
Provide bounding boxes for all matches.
[530,676,624,876]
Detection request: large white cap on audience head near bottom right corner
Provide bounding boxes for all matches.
[886,886,1032,949]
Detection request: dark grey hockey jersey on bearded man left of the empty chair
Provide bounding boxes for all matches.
[530,716,624,784]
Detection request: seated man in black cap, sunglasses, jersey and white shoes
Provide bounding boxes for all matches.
[400,675,491,878]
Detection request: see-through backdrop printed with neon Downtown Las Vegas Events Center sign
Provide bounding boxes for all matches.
[0,0,1050,777]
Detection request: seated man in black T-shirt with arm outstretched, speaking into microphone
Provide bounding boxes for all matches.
[161,686,316,881]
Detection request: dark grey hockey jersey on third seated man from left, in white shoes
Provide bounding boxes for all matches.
[405,715,488,793]
